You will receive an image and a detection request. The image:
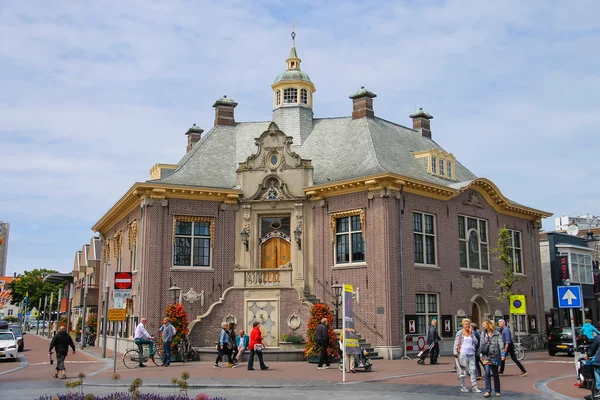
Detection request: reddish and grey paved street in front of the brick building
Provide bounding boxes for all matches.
[0,335,587,400]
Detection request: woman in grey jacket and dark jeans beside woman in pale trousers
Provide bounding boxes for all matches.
[479,320,506,397]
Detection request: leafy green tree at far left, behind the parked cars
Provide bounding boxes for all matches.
[10,268,61,309]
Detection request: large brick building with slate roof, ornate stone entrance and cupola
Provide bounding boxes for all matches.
[93,31,550,358]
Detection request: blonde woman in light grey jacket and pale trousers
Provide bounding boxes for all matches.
[454,318,481,393]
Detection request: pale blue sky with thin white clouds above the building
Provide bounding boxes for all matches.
[0,0,600,275]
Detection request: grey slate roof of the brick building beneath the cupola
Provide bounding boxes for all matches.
[148,112,476,189]
